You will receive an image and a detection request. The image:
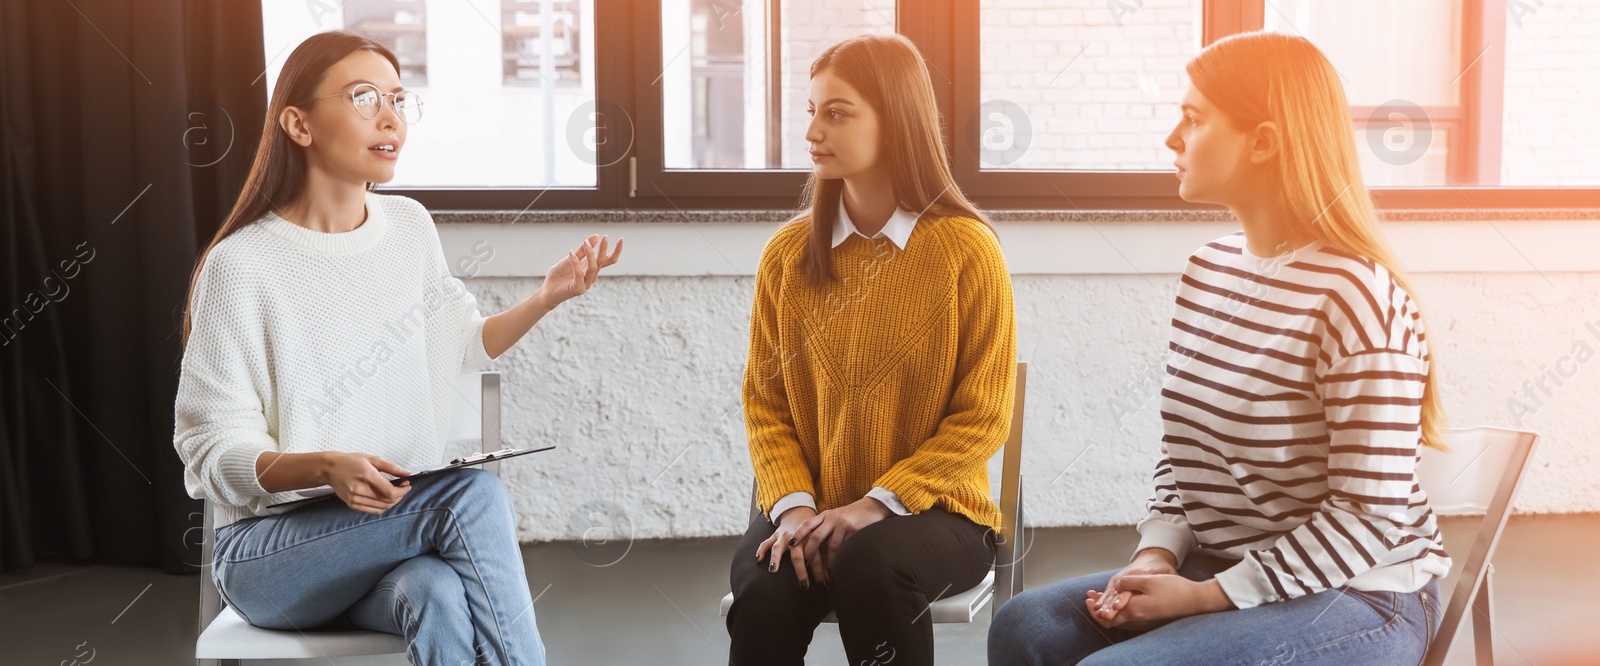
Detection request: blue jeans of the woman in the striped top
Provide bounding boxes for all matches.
[989,552,1440,666]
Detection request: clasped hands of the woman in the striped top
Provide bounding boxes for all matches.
[1083,548,1234,631]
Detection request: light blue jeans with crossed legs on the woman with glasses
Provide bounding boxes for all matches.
[213,469,544,666]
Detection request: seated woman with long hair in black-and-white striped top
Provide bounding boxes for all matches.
[989,32,1450,664]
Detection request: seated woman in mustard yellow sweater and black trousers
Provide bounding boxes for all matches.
[728,35,1016,666]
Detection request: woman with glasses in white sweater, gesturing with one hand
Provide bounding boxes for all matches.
[173,32,622,664]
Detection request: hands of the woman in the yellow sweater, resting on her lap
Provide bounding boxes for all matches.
[755,498,893,589]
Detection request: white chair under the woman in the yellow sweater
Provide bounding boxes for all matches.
[720,362,1027,624]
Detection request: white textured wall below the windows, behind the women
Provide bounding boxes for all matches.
[440,221,1600,541]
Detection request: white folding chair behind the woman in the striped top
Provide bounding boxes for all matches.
[1418,427,1539,666]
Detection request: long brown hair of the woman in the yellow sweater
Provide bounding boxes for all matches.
[794,35,994,287]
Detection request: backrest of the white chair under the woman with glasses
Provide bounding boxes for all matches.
[200,371,501,632]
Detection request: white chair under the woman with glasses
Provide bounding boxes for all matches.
[195,371,501,666]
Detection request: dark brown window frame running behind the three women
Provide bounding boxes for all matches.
[381,0,1600,211]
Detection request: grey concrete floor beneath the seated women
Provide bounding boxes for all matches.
[0,514,1600,666]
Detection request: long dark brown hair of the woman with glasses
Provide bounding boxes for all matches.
[182,30,400,347]
